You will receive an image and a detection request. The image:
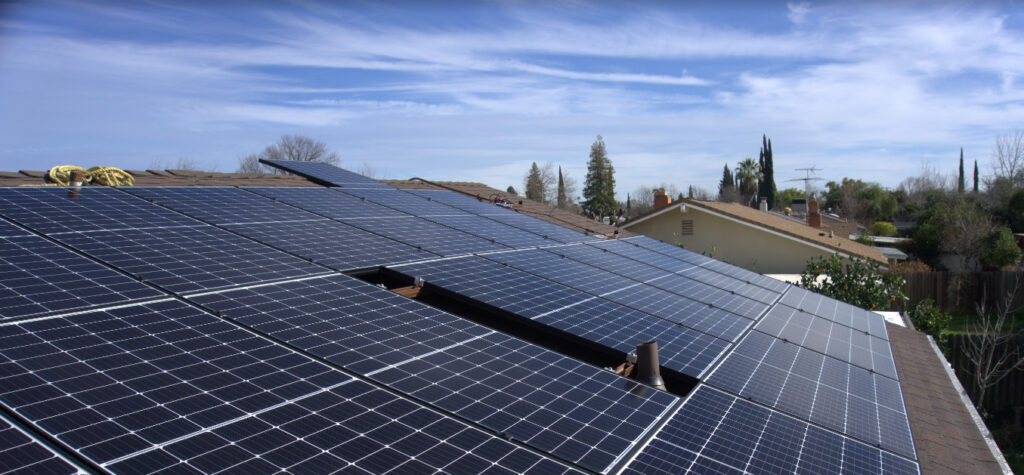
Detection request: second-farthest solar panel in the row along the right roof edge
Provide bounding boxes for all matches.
[756,305,898,379]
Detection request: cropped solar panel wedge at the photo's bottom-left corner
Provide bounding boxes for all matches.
[0,416,86,474]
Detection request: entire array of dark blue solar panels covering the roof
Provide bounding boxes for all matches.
[0,162,918,473]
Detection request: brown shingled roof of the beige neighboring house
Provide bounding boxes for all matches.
[623,199,888,264]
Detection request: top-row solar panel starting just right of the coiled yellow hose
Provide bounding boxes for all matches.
[125,186,321,224]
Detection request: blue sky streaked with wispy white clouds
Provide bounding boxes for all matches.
[0,0,1024,200]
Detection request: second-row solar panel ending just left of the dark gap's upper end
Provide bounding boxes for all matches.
[51,225,328,293]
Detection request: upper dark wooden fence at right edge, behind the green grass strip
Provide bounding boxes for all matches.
[900,272,1024,313]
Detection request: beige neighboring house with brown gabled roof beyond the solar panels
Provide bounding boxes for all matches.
[623,199,889,274]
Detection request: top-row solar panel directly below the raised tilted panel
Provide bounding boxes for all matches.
[245,186,410,219]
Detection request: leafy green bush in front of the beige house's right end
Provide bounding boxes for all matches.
[798,254,906,310]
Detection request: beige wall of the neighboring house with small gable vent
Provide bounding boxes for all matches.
[629,207,833,273]
